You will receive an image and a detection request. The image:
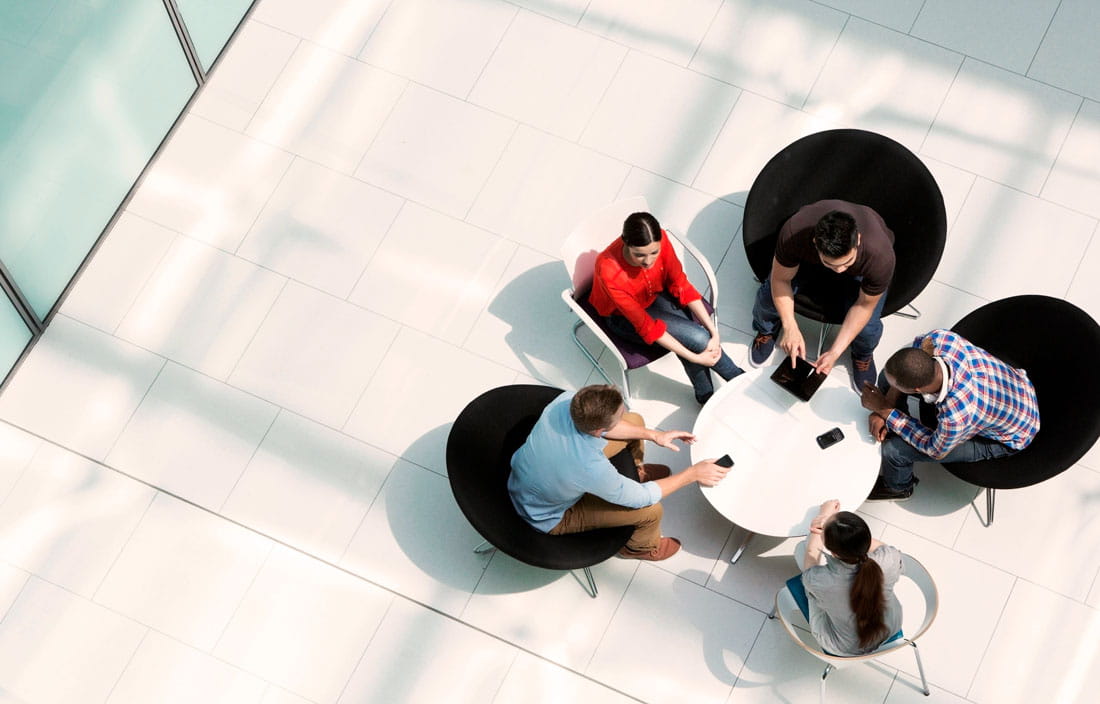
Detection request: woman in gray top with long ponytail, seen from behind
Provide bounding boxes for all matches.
[802,501,902,656]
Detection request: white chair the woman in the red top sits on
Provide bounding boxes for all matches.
[561,196,718,398]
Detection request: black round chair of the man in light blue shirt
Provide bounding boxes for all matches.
[447,384,634,598]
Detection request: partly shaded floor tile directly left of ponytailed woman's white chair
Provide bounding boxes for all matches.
[586,564,766,703]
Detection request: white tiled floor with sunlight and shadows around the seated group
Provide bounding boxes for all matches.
[0,0,1100,704]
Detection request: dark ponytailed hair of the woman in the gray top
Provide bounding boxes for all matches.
[824,510,889,649]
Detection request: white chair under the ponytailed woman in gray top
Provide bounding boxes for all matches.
[768,553,939,704]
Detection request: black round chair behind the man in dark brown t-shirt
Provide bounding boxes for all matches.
[741,130,947,325]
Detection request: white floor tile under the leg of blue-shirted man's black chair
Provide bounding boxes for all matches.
[462,552,639,672]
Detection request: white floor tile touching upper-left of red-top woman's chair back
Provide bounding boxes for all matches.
[466,127,629,259]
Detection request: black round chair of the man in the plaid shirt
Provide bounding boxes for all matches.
[922,296,1100,526]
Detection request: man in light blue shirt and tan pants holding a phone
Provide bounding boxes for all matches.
[508,386,728,560]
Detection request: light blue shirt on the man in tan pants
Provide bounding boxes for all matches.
[508,393,661,532]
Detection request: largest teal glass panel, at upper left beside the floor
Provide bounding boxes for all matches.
[0,0,197,318]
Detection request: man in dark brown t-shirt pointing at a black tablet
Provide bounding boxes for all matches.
[749,200,894,393]
